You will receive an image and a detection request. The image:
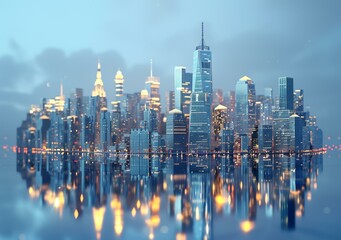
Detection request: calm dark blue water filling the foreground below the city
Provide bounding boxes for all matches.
[0,154,341,239]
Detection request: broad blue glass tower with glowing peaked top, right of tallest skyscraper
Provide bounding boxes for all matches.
[235,76,256,136]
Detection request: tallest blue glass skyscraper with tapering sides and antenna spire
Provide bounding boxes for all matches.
[189,23,212,156]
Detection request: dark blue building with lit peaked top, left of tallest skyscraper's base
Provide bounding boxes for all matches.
[166,109,187,153]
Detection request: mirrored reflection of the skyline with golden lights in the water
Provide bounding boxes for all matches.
[17,153,323,239]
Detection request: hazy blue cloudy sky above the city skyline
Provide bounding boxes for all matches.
[0,0,341,145]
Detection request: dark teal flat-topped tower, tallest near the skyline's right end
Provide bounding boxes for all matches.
[278,77,294,111]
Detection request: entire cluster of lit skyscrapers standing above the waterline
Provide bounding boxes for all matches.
[17,23,323,175]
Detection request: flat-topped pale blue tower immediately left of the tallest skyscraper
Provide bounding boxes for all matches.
[174,67,192,119]
